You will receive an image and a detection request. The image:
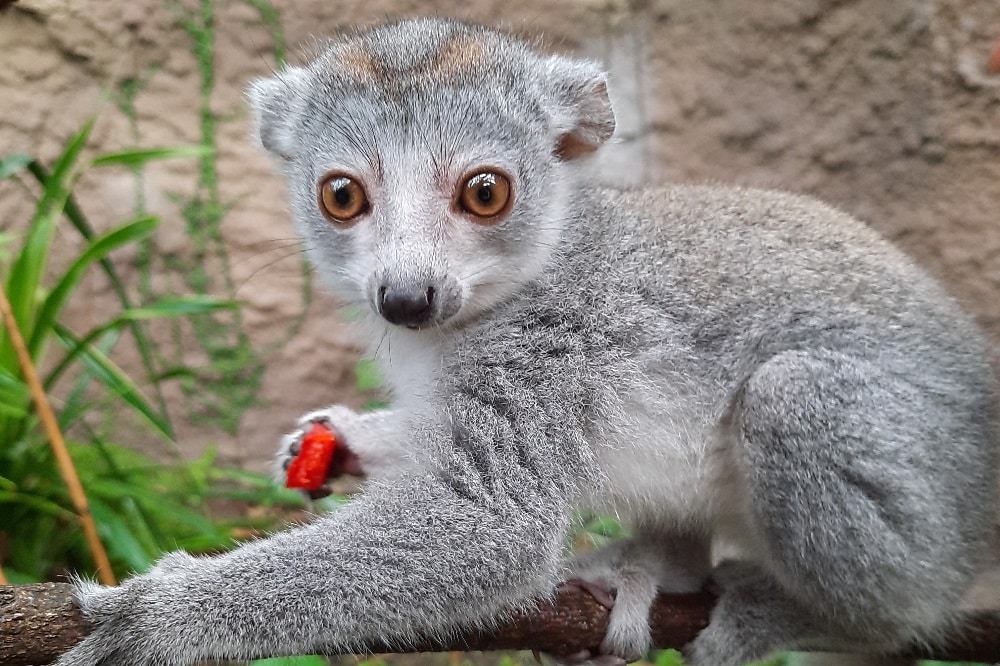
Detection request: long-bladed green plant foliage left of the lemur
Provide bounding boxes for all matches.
[0,126,298,583]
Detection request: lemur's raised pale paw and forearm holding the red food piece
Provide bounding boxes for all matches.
[274,405,407,478]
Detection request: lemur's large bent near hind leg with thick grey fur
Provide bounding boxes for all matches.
[687,351,968,666]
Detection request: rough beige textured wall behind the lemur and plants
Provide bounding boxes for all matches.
[0,0,1000,469]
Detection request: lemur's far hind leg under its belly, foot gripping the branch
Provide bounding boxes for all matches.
[569,534,711,661]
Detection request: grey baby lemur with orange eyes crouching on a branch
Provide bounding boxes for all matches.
[60,14,1000,666]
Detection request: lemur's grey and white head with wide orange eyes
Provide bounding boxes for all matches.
[249,19,615,328]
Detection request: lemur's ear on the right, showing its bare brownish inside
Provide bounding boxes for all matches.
[546,56,615,160]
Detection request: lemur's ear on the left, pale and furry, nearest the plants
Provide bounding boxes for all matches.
[246,67,306,161]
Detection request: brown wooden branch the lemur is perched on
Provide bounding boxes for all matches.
[0,583,1000,666]
